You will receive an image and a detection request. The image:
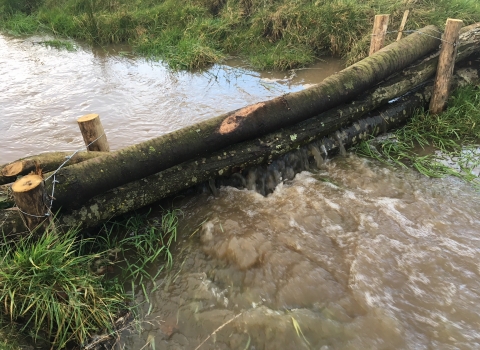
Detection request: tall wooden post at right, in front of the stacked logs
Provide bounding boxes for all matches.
[430,18,463,114]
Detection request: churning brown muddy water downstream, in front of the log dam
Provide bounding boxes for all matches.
[116,155,480,350]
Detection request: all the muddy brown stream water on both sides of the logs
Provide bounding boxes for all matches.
[0,36,480,350]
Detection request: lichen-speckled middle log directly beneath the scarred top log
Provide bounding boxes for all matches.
[0,61,480,233]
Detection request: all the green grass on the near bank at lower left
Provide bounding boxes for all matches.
[0,211,178,349]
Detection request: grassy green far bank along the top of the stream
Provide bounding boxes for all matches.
[0,0,480,69]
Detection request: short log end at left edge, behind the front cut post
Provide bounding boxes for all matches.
[0,152,103,185]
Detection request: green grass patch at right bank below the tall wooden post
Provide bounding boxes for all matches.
[356,86,480,188]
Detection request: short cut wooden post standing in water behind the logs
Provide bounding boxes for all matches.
[77,114,110,152]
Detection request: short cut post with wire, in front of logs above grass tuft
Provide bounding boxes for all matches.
[12,174,51,231]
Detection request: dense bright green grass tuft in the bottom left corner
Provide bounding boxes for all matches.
[0,230,124,348]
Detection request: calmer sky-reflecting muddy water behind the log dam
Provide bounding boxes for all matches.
[0,35,343,164]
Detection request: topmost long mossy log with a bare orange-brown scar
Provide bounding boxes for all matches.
[48,26,439,211]
